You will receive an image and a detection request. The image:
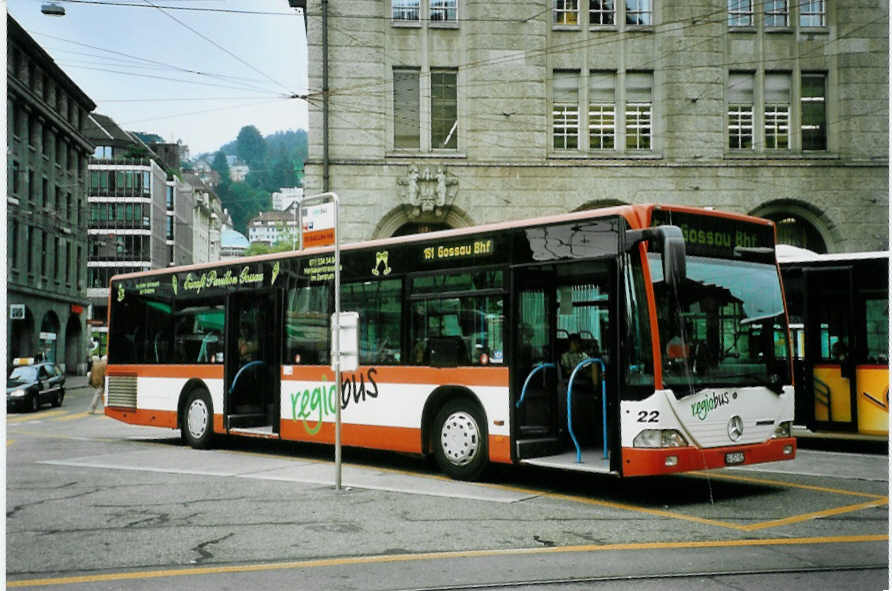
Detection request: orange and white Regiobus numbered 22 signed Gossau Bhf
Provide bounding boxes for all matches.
[105,205,796,479]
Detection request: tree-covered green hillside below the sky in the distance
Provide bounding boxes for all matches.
[199,125,307,235]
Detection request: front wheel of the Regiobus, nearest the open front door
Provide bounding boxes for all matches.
[433,398,489,480]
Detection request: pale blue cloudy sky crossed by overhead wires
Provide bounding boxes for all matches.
[6,0,308,156]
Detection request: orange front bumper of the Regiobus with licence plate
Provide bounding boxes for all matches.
[622,437,796,476]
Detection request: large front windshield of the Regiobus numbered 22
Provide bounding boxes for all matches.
[648,254,790,398]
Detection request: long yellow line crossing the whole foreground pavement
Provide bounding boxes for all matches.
[6,534,889,588]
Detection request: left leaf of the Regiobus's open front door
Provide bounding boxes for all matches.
[511,266,559,457]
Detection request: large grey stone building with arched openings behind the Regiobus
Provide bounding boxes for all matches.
[304,0,889,252]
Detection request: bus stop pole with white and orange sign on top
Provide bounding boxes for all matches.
[300,192,343,490]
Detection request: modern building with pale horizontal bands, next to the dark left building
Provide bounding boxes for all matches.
[84,113,193,348]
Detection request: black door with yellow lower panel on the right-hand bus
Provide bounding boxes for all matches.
[803,267,858,431]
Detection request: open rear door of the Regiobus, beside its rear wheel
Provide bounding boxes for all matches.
[223,290,281,433]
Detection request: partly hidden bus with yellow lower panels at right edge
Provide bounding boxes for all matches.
[778,247,889,436]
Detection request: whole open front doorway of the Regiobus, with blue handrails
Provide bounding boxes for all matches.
[512,259,616,466]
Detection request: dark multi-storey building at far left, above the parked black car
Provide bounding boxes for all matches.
[4,15,96,373]
